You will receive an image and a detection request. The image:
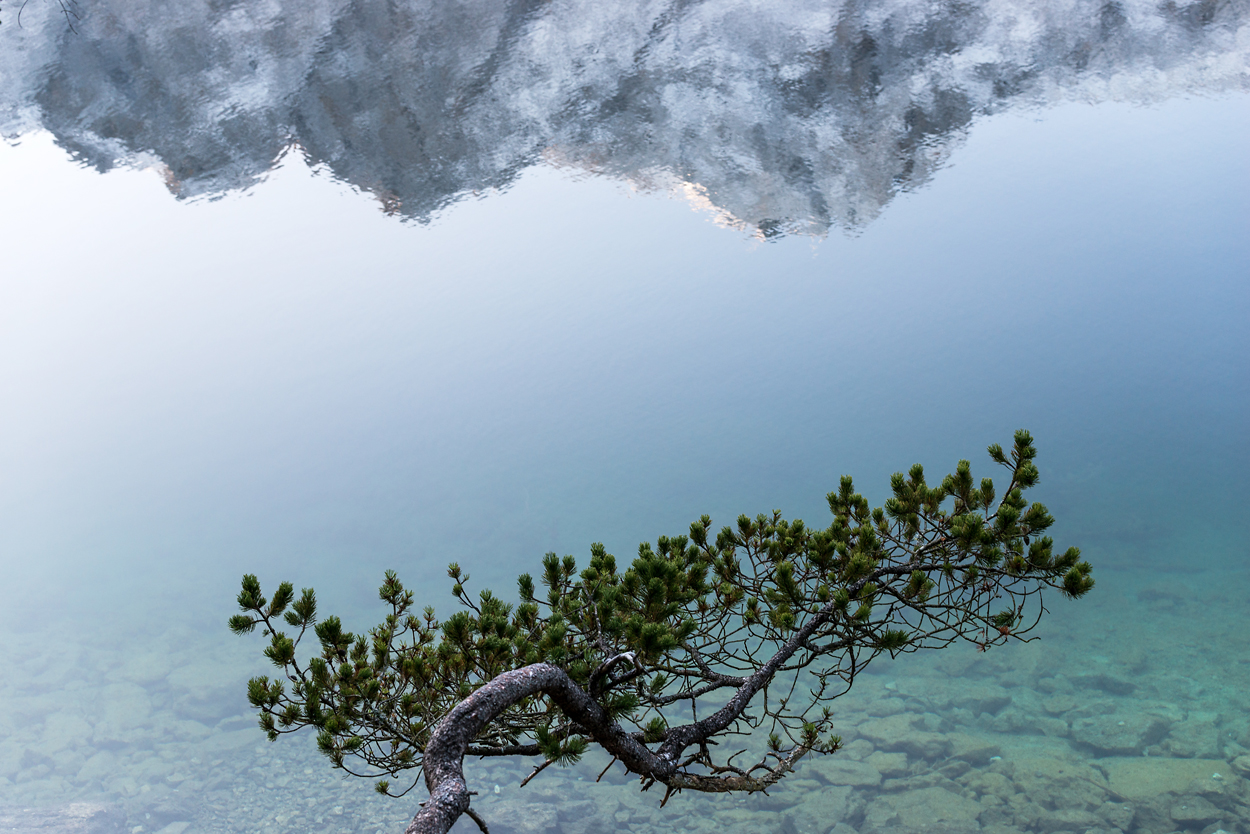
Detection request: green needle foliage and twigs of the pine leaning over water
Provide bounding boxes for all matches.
[229,431,1094,793]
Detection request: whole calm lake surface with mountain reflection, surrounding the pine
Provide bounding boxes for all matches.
[0,0,1250,834]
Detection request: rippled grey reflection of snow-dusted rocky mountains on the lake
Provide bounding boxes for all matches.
[0,0,1250,235]
